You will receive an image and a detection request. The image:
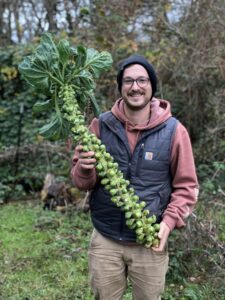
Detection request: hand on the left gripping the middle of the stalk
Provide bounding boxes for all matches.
[75,145,96,173]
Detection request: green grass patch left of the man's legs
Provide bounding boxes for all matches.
[0,204,92,300]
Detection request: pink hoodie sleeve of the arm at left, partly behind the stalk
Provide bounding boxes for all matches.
[70,118,100,190]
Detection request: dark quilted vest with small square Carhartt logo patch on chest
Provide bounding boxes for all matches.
[90,112,178,241]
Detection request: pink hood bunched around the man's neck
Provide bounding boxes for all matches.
[111,98,172,131]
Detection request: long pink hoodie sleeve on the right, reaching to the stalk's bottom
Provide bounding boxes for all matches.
[163,123,199,231]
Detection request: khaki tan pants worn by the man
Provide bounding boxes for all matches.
[89,230,168,300]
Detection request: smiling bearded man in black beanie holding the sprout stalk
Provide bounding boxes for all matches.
[71,55,198,300]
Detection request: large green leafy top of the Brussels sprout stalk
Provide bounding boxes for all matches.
[19,33,112,140]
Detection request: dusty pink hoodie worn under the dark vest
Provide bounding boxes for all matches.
[71,98,198,231]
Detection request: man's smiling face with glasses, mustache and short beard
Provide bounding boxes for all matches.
[121,64,152,111]
